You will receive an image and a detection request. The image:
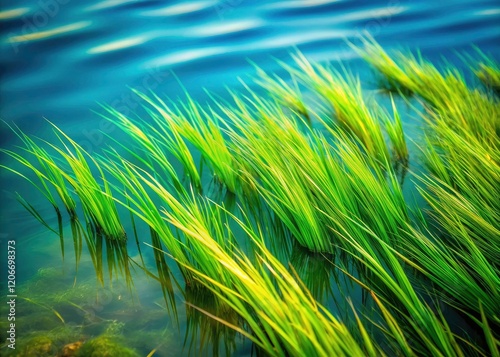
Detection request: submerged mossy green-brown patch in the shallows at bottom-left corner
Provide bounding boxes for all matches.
[0,268,171,357]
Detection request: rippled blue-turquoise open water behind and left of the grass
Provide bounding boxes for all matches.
[0,0,500,356]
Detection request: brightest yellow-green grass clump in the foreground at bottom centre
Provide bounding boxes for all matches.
[168,206,380,356]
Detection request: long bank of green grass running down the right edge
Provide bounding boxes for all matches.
[378,38,500,348]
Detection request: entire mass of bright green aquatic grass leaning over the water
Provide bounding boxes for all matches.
[2,39,500,356]
